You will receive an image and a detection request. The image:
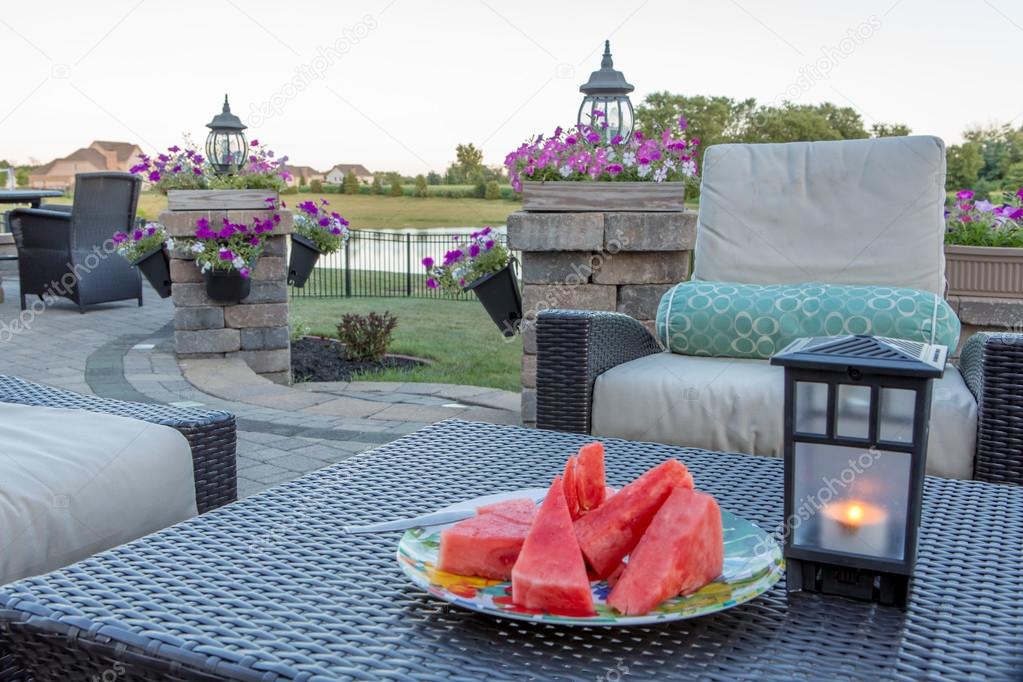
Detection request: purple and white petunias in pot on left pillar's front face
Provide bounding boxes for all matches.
[185,200,280,278]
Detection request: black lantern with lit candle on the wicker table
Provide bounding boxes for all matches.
[771,335,947,606]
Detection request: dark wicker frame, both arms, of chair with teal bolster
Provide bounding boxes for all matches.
[536,310,1023,485]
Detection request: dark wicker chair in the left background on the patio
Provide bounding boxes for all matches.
[8,173,142,313]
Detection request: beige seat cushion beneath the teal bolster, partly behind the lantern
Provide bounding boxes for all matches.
[592,353,977,479]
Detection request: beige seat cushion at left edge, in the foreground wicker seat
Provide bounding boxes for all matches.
[0,403,197,585]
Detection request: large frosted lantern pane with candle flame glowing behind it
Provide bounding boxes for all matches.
[792,443,913,561]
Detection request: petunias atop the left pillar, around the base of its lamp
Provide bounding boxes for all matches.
[129,137,292,194]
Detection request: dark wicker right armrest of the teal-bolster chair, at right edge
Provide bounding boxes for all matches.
[960,331,1023,485]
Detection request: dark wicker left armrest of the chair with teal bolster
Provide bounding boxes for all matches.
[536,310,661,434]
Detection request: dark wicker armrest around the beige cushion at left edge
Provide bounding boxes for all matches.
[0,374,238,511]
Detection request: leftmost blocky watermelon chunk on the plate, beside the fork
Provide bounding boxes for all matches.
[437,511,532,580]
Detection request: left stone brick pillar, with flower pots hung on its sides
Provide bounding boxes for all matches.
[160,211,292,383]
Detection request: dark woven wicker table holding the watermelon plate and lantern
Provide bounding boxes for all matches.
[0,421,1023,680]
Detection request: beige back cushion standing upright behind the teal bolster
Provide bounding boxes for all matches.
[693,136,945,295]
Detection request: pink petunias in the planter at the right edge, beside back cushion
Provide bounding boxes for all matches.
[945,187,1023,248]
